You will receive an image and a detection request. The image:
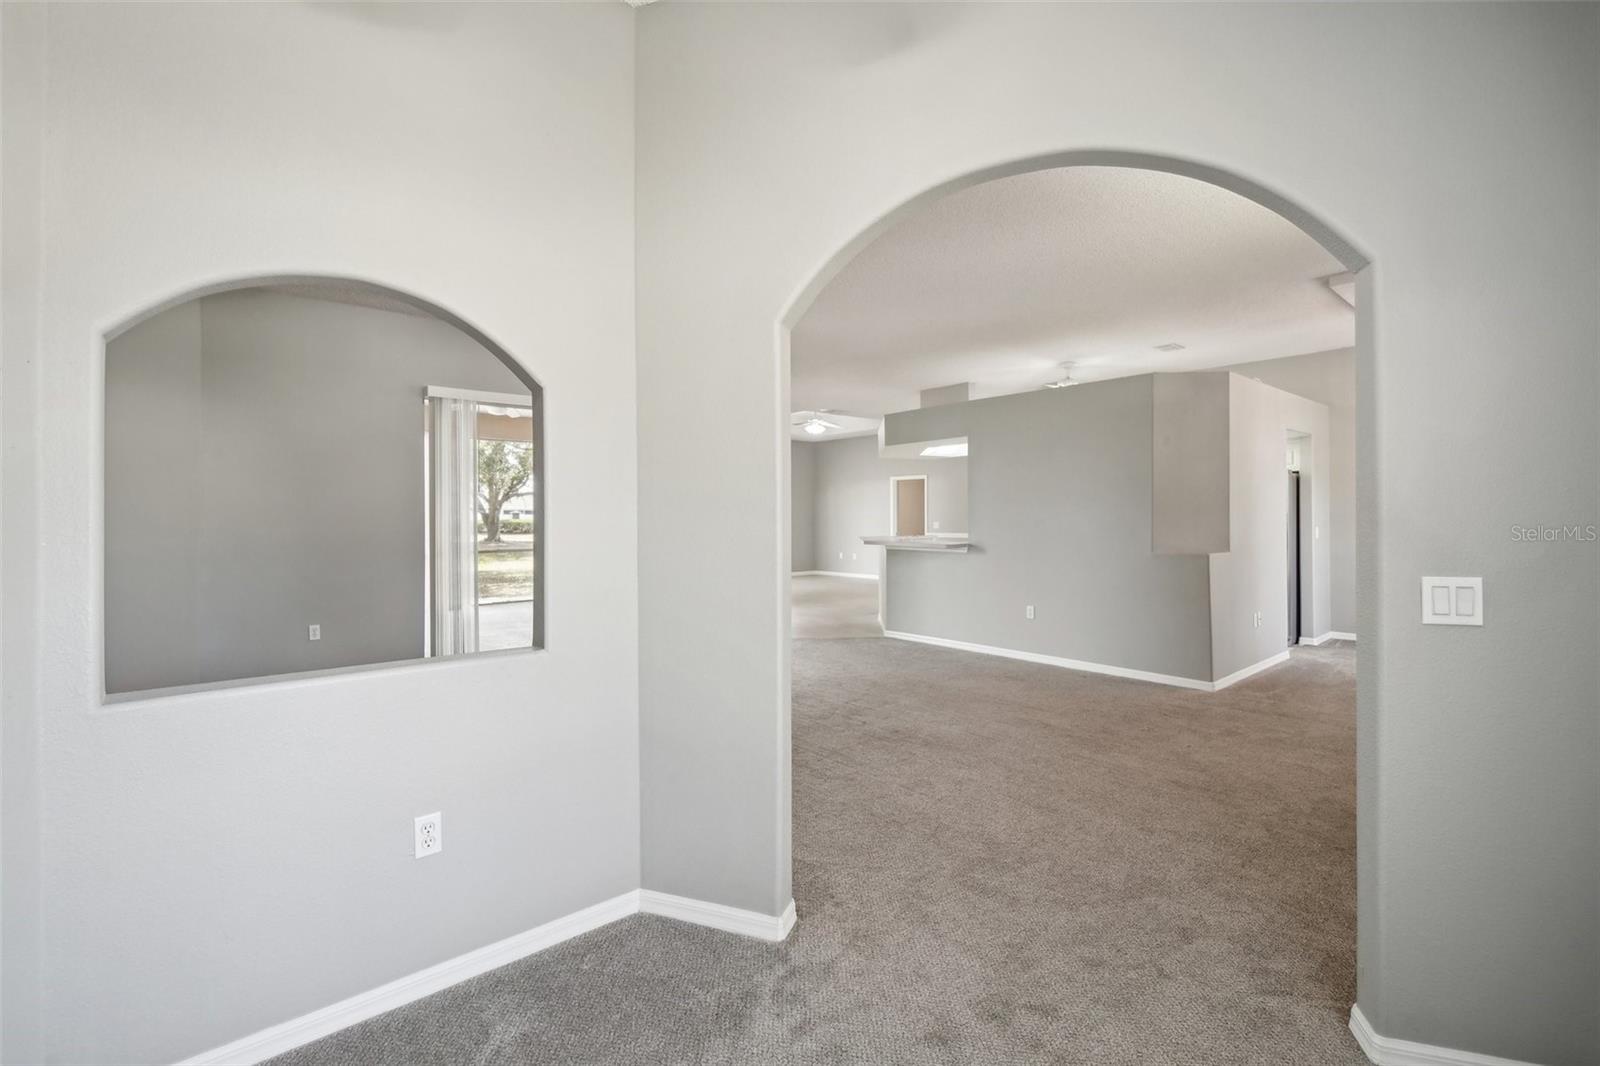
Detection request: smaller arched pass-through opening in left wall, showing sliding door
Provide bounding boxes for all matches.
[96,274,546,703]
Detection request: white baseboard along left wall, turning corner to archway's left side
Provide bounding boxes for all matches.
[178,888,795,1066]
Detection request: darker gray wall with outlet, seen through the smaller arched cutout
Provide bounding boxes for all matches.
[106,290,530,693]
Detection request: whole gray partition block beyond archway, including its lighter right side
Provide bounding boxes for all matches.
[883,371,1330,682]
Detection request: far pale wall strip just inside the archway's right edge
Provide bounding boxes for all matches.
[1229,347,1357,632]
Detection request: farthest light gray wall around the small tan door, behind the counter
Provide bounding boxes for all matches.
[790,437,966,575]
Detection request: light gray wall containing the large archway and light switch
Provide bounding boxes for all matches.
[637,3,1600,1064]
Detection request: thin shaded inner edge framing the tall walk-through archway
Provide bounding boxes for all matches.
[773,149,1381,1024]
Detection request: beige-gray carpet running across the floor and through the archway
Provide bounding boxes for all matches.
[272,627,1365,1066]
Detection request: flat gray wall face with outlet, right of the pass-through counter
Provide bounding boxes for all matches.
[883,376,1203,680]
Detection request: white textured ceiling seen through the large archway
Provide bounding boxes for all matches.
[790,166,1355,415]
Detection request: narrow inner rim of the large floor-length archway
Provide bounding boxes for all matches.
[774,149,1379,1056]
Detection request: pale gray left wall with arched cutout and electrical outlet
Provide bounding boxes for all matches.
[0,5,638,1063]
